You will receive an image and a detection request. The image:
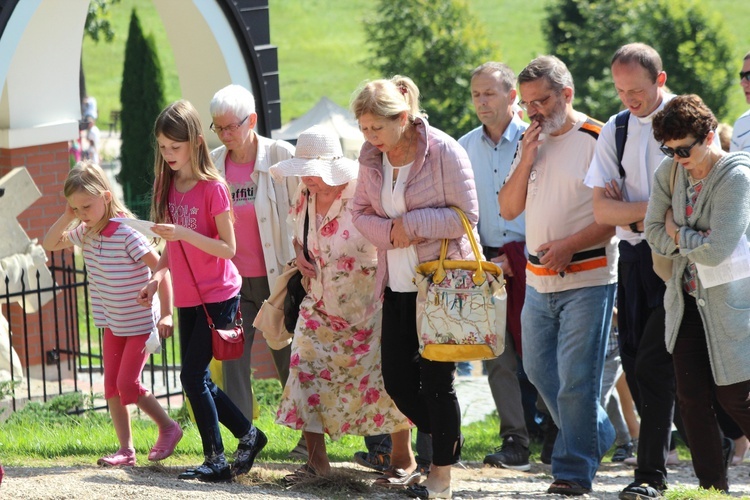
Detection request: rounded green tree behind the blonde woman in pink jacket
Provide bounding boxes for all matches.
[364,0,499,137]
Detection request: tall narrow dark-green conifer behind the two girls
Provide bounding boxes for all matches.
[118,10,164,219]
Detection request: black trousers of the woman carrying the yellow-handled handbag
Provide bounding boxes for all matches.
[381,288,461,466]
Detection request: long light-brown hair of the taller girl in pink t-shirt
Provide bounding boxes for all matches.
[151,100,234,223]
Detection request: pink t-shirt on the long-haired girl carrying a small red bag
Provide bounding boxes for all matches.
[167,181,242,307]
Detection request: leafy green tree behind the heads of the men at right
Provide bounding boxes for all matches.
[544,0,737,120]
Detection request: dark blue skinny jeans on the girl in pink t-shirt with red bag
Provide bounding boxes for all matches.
[177,297,252,457]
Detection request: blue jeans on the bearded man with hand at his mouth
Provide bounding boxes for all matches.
[521,284,616,488]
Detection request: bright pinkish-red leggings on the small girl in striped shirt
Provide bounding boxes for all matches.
[103,328,149,406]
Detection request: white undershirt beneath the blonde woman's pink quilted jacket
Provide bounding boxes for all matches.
[380,154,419,292]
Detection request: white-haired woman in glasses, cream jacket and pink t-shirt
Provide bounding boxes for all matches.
[209,85,299,446]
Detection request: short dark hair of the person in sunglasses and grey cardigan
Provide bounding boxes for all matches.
[653,94,719,144]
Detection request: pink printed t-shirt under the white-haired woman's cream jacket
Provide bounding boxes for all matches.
[224,155,266,278]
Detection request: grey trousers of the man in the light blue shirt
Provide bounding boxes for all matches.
[484,332,541,448]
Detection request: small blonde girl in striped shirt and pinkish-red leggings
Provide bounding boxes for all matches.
[42,162,182,466]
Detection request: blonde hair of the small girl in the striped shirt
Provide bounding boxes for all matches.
[63,161,135,236]
